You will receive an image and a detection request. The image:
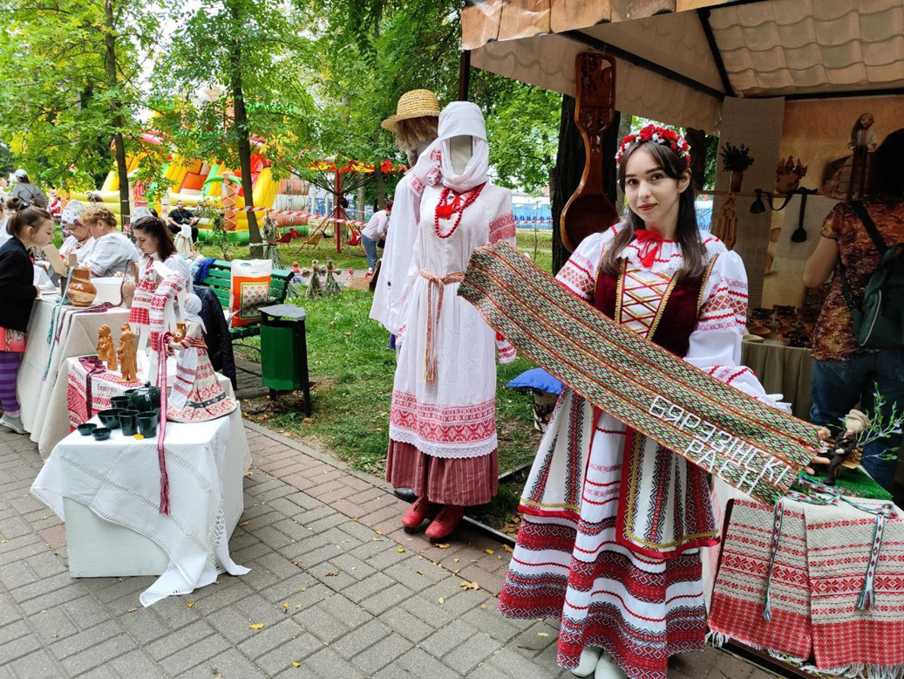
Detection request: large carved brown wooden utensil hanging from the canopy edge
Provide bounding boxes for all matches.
[559,52,618,251]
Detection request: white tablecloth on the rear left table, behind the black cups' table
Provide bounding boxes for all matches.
[16,298,129,456]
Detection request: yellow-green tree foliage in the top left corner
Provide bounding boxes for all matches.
[0,0,157,197]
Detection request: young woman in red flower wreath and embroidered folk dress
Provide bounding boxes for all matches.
[499,125,767,679]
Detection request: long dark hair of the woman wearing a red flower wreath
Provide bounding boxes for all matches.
[600,140,706,278]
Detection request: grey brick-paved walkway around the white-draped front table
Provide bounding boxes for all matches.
[0,423,771,679]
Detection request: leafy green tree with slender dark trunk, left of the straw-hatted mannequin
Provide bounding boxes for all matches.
[150,0,312,243]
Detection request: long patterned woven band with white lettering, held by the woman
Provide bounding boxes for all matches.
[458,241,819,506]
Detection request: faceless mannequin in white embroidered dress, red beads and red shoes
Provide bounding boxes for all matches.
[386,101,515,540]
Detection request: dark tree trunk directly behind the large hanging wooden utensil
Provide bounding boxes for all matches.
[550,94,621,274]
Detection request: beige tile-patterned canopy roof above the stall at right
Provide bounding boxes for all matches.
[462,0,904,130]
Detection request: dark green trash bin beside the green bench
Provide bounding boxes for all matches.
[260,304,311,415]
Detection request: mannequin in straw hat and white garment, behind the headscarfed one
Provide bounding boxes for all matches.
[370,90,439,336]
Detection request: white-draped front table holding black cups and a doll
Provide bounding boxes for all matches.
[31,407,251,606]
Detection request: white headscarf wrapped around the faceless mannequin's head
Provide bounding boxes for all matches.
[412,101,490,193]
